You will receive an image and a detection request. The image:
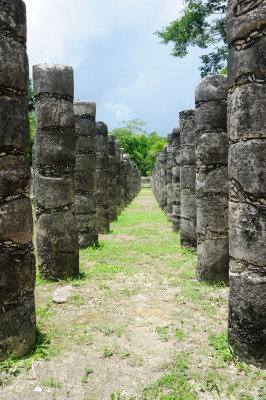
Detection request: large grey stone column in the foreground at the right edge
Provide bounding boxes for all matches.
[227,0,266,367]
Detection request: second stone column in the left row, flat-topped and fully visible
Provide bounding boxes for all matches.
[33,64,79,280]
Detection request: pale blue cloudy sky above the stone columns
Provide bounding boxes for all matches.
[24,0,204,136]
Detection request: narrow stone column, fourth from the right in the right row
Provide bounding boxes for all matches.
[172,128,181,232]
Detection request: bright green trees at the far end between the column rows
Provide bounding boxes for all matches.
[110,118,166,176]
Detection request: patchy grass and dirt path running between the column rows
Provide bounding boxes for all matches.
[0,189,264,400]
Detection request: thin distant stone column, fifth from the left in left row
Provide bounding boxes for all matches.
[107,134,117,222]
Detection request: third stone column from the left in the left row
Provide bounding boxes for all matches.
[74,101,98,248]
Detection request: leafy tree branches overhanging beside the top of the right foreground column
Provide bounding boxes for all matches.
[155,0,228,77]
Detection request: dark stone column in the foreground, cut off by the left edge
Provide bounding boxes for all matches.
[0,0,35,360]
